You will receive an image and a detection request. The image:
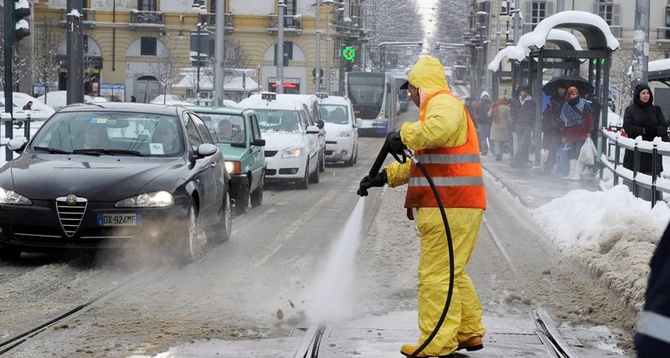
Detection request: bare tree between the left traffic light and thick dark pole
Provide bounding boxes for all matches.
[31,20,61,98]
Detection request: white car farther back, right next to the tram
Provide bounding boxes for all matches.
[317,93,363,166]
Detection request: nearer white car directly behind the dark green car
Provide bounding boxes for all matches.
[237,92,320,189]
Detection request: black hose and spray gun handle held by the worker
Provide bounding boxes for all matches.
[368,142,455,358]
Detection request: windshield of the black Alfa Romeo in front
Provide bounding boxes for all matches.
[29,111,184,156]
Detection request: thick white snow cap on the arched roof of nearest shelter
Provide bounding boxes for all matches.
[530,11,619,51]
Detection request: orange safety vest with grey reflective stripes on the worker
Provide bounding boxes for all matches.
[405,89,486,209]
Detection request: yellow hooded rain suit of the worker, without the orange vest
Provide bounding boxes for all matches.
[386,57,486,356]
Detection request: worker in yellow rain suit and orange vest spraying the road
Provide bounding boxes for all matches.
[358,56,486,357]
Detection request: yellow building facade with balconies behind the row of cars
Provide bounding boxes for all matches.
[26,0,362,102]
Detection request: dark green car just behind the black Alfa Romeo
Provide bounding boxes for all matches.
[191,107,266,214]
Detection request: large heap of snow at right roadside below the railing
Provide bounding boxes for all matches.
[532,185,670,309]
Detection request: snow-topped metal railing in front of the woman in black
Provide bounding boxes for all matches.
[600,129,670,207]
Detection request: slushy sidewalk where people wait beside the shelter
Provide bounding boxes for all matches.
[481,153,599,208]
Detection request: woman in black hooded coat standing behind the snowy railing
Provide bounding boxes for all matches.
[623,83,668,200]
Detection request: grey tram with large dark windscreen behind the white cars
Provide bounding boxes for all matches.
[344,72,398,135]
